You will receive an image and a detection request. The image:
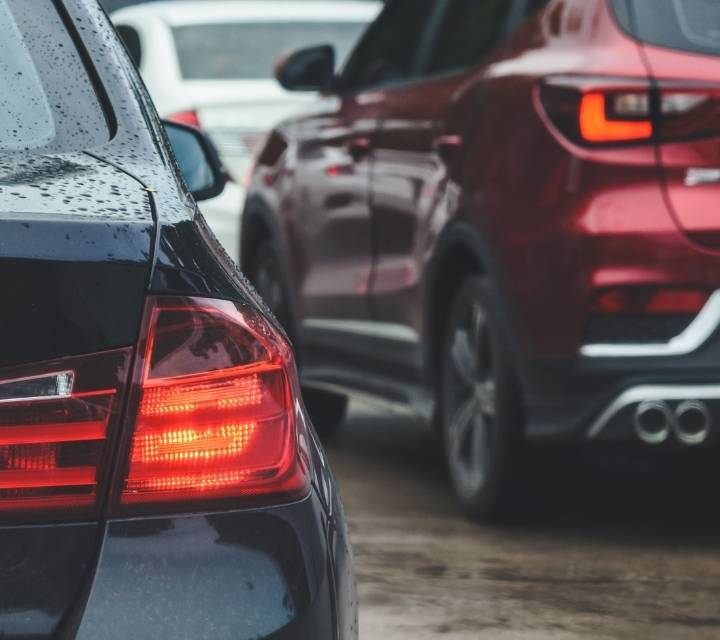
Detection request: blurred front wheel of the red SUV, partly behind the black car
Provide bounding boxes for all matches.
[247,238,295,340]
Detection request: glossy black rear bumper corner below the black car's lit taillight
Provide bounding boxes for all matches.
[69,493,348,640]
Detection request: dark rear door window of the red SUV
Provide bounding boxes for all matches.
[427,0,512,74]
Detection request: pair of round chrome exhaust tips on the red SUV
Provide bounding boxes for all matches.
[634,400,713,445]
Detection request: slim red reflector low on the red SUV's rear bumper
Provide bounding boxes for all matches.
[591,287,710,316]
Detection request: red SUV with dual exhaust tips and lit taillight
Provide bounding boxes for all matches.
[242,0,720,518]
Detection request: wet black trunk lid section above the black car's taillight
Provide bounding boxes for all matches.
[0,155,154,367]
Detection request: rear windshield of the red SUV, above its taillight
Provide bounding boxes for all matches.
[615,0,720,55]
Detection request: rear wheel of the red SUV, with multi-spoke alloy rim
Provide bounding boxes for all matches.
[439,276,552,521]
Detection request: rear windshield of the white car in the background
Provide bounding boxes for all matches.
[173,22,366,80]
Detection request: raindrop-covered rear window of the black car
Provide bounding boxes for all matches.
[0,0,109,153]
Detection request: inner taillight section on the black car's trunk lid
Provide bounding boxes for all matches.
[0,349,132,519]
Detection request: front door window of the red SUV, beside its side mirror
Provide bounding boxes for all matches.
[343,0,444,89]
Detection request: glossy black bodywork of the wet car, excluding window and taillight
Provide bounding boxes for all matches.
[0,0,357,640]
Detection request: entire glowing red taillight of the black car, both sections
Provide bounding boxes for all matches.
[0,297,310,521]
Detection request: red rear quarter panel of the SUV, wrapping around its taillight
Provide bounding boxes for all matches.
[455,0,677,359]
